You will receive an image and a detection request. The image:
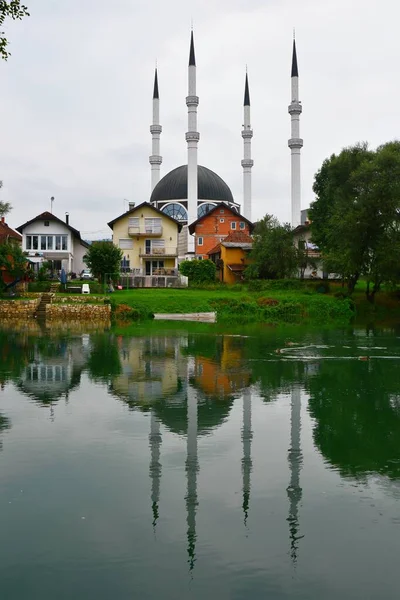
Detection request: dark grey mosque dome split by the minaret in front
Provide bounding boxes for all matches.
[150,165,234,203]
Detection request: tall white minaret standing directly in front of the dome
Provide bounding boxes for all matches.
[186,31,200,254]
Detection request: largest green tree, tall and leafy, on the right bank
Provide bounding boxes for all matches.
[309,142,400,301]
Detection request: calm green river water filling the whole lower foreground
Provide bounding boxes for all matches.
[0,325,400,600]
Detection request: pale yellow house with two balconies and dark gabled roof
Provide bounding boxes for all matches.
[108,202,182,276]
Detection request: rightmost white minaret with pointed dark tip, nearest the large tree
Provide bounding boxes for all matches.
[288,39,303,227]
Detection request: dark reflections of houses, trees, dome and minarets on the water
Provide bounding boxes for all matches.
[0,330,400,584]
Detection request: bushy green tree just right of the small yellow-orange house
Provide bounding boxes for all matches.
[246,215,299,279]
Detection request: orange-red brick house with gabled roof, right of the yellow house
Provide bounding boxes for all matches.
[189,202,254,259]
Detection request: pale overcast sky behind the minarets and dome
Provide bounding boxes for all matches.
[0,0,400,239]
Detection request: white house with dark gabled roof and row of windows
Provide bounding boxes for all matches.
[17,211,88,273]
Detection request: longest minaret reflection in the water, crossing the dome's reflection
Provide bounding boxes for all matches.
[186,385,199,570]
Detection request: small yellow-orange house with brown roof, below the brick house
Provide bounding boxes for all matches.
[208,231,253,283]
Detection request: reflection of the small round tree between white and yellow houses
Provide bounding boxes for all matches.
[87,335,121,383]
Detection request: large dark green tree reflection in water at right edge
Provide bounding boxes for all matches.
[308,359,400,478]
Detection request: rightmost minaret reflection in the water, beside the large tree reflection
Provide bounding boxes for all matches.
[287,387,303,562]
